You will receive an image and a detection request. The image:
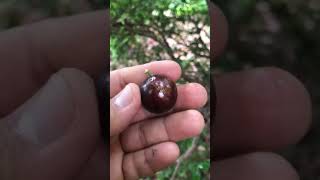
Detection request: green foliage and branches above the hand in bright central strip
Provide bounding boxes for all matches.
[110,0,210,86]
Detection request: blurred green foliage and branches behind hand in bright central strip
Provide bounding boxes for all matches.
[110,0,210,180]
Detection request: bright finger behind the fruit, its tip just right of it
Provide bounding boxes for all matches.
[133,83,208,122]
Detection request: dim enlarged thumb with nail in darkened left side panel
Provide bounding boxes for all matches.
[0,69,100,180]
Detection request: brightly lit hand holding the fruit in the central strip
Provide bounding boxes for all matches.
[110,61,207,180]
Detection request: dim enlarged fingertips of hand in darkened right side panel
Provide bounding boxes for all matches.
[211,4,311,180]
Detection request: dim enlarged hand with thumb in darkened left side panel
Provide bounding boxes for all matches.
[0,11,109,180]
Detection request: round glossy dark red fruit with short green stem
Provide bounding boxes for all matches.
[140,70,177,114]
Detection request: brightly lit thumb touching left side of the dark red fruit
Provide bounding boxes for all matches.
[110,83,141,136]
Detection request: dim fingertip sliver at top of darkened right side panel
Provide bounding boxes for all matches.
[209,2,228,60]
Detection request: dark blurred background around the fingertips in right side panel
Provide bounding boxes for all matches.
[213,0,320,180]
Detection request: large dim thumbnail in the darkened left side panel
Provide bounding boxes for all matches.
[13,72,74,147]
